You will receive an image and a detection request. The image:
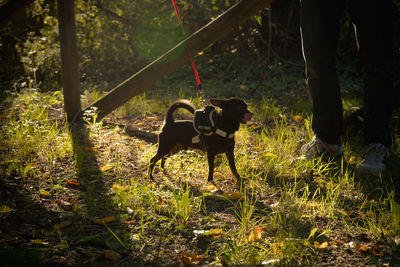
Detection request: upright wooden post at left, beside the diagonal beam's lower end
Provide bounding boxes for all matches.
[57,0,81,121]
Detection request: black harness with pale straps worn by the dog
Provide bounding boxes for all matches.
[192,106,235,144]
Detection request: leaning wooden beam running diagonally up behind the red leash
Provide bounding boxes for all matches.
[84,0,273,119]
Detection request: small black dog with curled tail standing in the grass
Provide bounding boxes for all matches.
[148,97,253,182]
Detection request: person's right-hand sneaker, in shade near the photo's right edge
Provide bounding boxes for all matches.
[357,143,389,176]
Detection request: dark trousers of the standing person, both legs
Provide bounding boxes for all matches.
[300,0,394,146]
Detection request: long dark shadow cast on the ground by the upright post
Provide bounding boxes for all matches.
[54,121,150,265]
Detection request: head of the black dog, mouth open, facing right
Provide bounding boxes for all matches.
[210,97,253,124]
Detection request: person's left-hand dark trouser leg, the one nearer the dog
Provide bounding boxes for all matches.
[300,0,345,147]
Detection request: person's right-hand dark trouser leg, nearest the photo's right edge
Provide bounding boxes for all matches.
[350,0,394,147]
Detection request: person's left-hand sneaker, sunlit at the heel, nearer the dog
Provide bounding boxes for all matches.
[301,136,343,160]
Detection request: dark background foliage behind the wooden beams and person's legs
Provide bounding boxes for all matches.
[0,0,400,97]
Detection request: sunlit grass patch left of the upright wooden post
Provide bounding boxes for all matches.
[0,90,72,177]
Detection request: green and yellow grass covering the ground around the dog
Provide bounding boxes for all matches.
[0,81,400,265]
